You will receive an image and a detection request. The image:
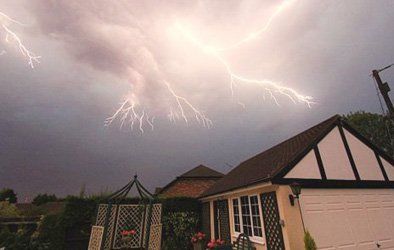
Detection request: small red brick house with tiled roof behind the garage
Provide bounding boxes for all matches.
[156,165,224,198]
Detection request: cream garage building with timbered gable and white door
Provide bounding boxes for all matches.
[200,115,394,250]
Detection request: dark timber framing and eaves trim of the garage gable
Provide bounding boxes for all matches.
[200,115,394,198]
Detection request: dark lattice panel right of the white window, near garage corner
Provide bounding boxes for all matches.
[261,192,285,250]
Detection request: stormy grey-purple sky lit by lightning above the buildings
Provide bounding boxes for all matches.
[0,0,394,201]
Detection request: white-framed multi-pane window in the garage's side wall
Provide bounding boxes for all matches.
[232,195,263,238]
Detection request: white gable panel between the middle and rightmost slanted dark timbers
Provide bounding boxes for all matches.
[344,129,384,180]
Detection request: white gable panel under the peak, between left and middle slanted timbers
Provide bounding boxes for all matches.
[318,127,356,180]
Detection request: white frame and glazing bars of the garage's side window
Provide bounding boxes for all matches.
[231,194,265,244]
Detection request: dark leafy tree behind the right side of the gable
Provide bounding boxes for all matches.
[344,111,394,157]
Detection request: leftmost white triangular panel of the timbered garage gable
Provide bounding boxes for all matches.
[285,150,321,179]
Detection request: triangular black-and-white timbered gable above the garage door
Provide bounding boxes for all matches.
[282,124,394,182]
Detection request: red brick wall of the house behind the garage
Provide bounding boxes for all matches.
[160,179,218,198]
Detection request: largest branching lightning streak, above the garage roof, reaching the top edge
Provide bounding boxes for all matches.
[176,1,314,107]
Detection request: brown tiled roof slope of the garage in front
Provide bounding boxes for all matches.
[202,115,341,197]
